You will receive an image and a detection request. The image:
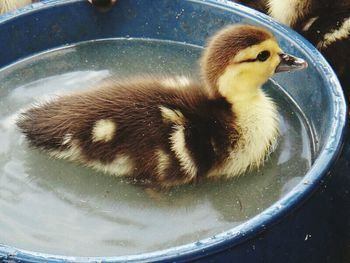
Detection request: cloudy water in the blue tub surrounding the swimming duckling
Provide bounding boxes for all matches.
[0,40,311,256]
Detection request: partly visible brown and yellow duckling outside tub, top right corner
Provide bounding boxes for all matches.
[268,0,350,102]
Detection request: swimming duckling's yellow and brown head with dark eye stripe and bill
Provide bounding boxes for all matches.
[201,25,307,103]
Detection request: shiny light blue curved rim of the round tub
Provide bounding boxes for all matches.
[0,0,346,262]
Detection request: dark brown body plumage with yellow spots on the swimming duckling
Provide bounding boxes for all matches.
[17,81,234,187]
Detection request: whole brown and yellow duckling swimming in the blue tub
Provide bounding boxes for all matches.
[16,25,307,189]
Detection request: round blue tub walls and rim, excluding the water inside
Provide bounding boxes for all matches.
[0,0,350,263]
